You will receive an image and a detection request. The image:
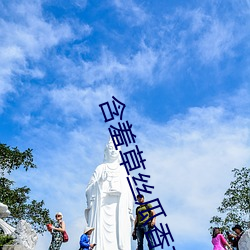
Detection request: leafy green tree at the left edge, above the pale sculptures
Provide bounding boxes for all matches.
[0,143,52,233]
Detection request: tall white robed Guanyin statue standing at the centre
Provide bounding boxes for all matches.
[85,139,134,250]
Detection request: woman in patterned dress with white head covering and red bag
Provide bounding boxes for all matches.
[49,212,66,250]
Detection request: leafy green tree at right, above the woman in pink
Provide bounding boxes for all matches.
[210,167,250,231]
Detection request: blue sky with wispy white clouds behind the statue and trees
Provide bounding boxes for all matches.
[0,0,250,250]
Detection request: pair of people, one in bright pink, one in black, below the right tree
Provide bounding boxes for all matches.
[212,225,244,250]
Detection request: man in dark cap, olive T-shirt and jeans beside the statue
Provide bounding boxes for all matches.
[132,194,155,250]
